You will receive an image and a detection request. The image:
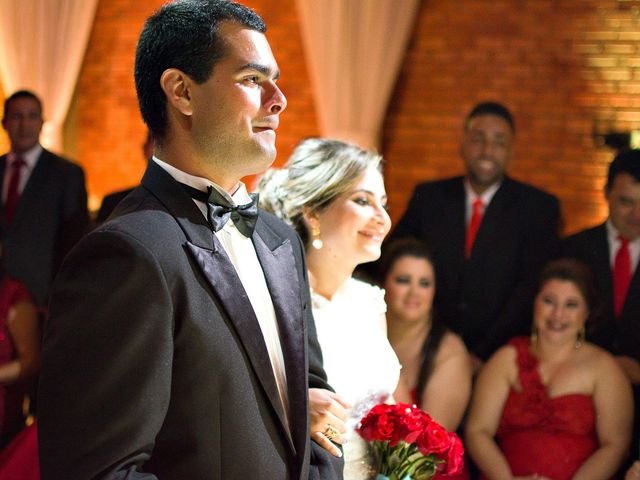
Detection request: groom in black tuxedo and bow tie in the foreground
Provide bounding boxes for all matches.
[39,0,341,480]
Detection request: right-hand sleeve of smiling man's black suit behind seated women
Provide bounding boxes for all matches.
[475,195,560,360]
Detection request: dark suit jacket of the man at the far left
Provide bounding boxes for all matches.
[0,150,89,305]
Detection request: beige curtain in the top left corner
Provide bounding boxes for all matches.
[0,0,98,151]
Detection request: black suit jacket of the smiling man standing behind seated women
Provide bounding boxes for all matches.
[392,177,560,359]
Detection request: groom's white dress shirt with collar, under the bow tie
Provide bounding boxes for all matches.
[152,156,289,428]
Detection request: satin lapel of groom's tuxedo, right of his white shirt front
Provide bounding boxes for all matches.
[253,222,308,452]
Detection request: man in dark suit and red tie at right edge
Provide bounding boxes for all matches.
[562,150,640,468]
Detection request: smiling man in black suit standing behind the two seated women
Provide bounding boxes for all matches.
[392,102,560,367]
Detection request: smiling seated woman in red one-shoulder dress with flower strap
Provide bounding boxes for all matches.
[466,259,633,480]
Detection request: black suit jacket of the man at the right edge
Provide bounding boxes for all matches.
[562,223,640,360]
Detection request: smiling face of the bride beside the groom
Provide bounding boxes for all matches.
[317,168,391,268]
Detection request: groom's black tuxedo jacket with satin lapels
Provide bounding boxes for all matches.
[39,162,342,480]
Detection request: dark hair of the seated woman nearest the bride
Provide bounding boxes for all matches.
[376,238,448,405]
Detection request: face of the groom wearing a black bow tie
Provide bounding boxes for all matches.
[191,22,287,179]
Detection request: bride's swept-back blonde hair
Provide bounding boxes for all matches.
[258,138,382,245]
